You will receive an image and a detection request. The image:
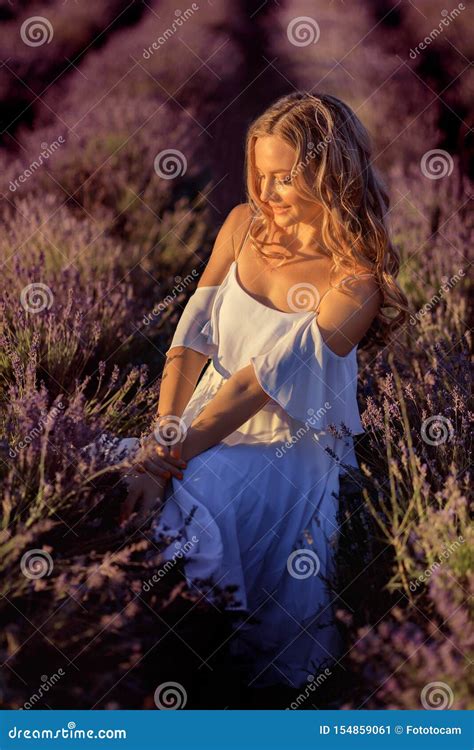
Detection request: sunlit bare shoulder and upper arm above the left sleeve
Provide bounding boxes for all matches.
[198,203,251,287]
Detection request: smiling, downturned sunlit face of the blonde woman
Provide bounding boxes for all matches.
[255,135,320,228]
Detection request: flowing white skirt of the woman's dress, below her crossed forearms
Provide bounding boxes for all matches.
[113,362,357,688]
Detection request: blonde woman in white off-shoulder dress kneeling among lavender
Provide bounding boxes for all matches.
[113,93,405,688]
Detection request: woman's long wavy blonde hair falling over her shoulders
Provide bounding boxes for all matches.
[245,92,410,346]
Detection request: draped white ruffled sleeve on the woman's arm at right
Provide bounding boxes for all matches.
[250,313,364,434]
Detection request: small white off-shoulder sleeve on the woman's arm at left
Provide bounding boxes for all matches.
[166,286,219,357]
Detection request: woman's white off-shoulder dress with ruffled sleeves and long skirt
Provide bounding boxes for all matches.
[113,231,364,688]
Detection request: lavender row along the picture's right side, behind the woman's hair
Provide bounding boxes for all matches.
[266,0,474,709]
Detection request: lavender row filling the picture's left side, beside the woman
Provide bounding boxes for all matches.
[0,3,252,708]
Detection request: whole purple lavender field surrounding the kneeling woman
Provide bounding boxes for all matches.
[0,0,474,710]
